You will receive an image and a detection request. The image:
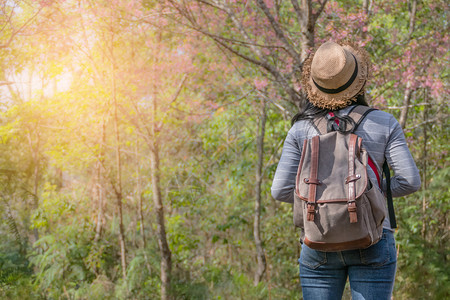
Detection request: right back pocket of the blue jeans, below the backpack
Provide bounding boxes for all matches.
[359,231,395,267]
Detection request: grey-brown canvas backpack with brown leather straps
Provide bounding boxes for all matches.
[294,105,395,252]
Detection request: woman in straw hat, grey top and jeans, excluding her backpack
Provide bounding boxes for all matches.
[272,43,420,300]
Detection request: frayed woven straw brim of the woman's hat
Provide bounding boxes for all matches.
[301,41,371,110]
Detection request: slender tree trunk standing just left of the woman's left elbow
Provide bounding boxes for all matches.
[253,99,267,286]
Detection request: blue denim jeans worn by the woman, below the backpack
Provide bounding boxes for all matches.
[299,229,397,300]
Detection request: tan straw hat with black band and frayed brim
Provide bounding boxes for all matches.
[302,41,370,110]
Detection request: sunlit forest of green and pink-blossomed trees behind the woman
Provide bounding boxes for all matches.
[0,0,450,299]
